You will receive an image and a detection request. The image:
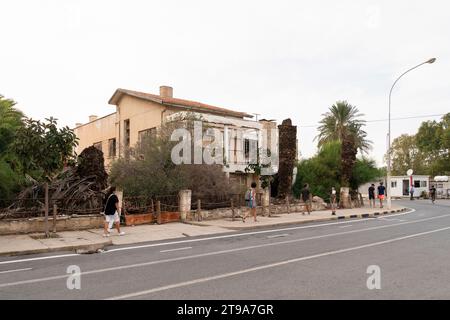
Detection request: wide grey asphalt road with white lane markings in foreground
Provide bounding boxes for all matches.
[0,200,450,300]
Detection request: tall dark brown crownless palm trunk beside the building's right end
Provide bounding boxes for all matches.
[278,119,297,199]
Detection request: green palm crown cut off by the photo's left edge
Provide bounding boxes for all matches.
[0,95,24,154]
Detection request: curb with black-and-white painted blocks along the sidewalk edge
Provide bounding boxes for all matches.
[184,207,411,231]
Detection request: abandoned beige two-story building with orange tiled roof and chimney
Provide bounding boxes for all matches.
[74,86,278,185]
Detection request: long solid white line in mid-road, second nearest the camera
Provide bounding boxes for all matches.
[0,210,442,288]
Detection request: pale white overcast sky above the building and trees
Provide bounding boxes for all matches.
[0,0,450,165]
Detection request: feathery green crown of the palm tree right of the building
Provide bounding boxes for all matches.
[316,101,372,153]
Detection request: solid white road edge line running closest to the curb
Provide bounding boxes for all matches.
[0,208,416,265]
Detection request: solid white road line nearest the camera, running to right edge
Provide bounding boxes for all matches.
[106,227,450,300]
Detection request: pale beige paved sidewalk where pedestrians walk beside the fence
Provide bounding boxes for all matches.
[0,206,407,256]
